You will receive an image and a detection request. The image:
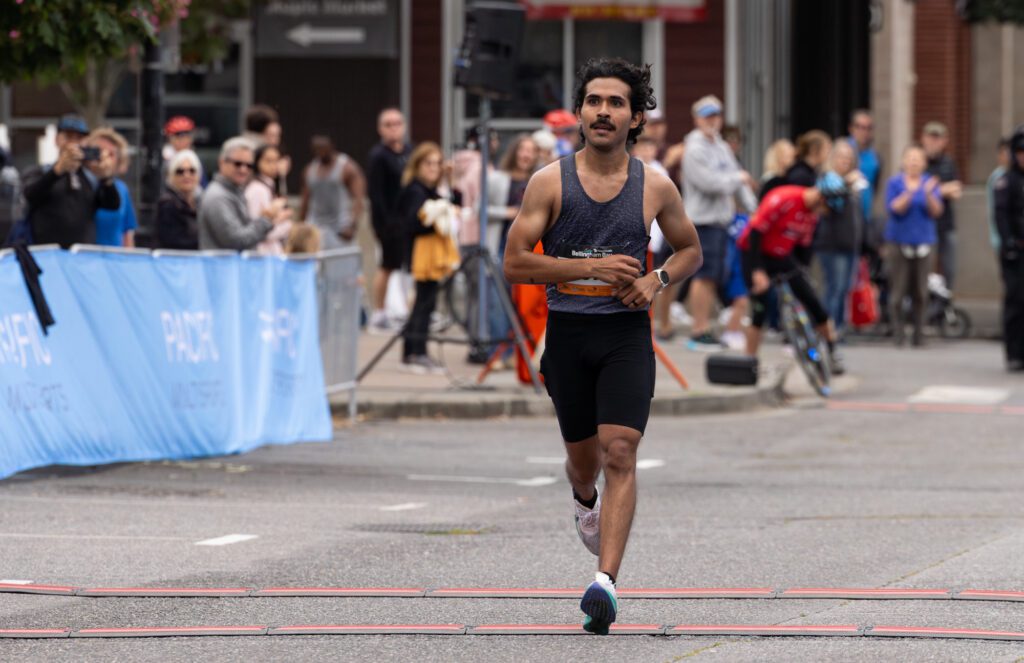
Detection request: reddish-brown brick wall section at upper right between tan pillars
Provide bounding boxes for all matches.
[912,0,971,176]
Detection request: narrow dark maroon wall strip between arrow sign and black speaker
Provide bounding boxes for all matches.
[410,0,444,142]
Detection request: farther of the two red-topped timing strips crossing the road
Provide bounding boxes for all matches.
[6,583,1024,603]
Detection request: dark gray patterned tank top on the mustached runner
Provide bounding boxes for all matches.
[542,155,650,314]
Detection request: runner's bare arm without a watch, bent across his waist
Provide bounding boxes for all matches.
[505,161,640,286]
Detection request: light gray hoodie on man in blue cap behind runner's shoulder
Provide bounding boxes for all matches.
[683,129,757,226]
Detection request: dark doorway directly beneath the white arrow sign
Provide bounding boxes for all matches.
[255,57,399,194]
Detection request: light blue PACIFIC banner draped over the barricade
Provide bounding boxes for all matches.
[0,250,332,479]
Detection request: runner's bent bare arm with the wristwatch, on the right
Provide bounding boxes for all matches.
[615,168,703,307]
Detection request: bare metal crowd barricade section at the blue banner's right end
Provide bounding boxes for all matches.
[311,247,362,421]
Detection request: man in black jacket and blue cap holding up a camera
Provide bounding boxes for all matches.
[25,115,121,249]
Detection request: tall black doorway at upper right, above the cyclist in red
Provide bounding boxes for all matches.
[792,0,870,136]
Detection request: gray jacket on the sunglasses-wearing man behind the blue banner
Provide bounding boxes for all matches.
[199,174,273,251]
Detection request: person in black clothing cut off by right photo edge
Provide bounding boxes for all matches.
[994,124,1024,372]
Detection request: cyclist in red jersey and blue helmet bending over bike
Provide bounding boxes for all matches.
[736,171,848,375]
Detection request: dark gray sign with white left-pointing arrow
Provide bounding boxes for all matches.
[254,0,399,57]
